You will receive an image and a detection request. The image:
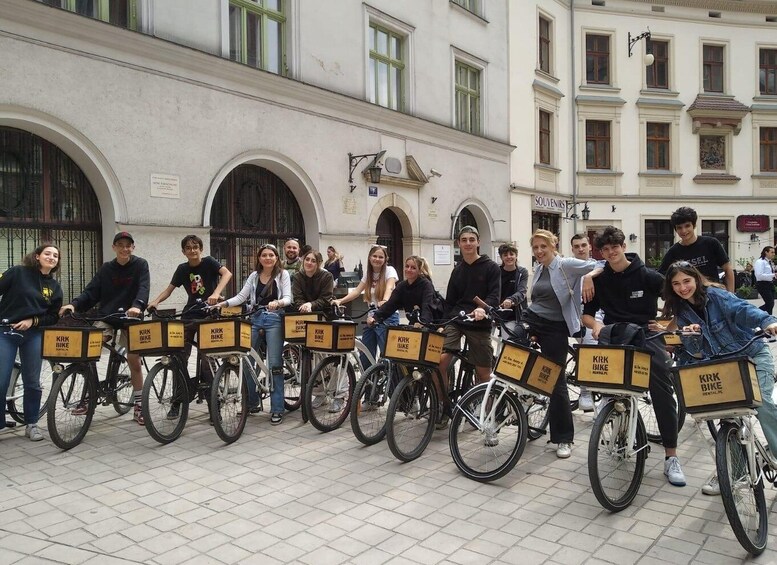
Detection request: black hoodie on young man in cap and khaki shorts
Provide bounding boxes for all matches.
[445,255,502,330]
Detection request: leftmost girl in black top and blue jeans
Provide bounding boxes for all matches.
[0,243,62,441]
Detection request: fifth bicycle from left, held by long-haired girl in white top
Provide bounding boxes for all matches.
[303,306,376,433]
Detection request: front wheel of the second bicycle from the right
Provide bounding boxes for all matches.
[588,399,649,512]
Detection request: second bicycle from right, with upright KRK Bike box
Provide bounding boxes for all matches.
[577,330,698,512]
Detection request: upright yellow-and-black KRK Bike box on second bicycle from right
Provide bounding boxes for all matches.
[575,345,653,392]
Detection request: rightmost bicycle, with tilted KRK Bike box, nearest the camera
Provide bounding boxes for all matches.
[675,331,777,555]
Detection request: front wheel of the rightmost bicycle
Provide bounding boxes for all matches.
[715,422,769,555]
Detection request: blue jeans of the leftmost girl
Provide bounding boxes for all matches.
[0,328,43,429]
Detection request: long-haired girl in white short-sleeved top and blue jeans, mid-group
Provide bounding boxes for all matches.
[332,245,399,370]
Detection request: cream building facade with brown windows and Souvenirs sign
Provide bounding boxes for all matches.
[509,0,777,269]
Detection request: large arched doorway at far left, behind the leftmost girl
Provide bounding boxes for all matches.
[0,127,102,301]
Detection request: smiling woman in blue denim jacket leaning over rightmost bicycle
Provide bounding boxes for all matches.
[664,261,777,494]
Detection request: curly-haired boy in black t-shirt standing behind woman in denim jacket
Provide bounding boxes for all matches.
[658,206,734,292]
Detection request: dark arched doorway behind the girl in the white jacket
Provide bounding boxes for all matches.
[210,165,305,293]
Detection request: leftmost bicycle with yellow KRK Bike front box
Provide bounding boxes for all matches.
[43,311,139,450]
